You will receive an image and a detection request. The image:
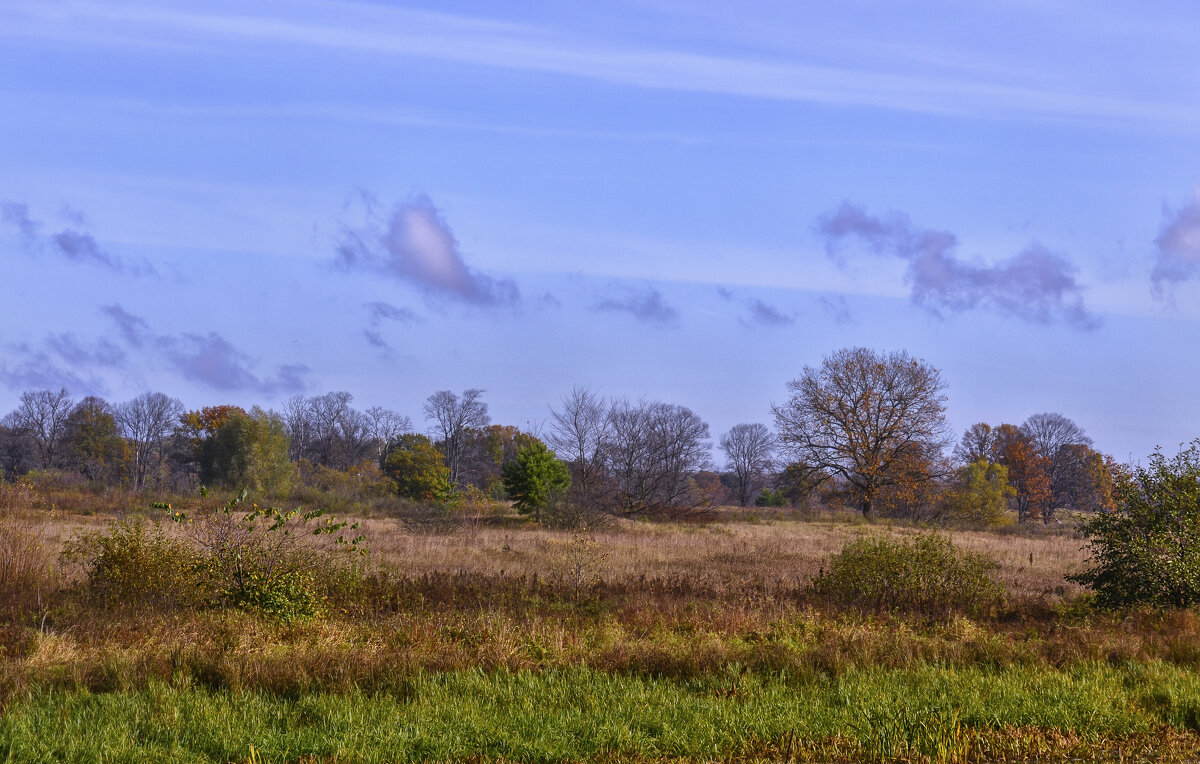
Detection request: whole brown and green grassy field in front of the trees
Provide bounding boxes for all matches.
[0,482,1200,762]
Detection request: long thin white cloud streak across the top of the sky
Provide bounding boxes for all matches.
[8,2,1200,125]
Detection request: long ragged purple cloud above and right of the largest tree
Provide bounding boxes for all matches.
[816,201,1099,330]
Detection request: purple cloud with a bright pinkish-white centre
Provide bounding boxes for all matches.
[335,197,521,306]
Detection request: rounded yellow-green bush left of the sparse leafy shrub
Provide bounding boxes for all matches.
[62,522,201,608]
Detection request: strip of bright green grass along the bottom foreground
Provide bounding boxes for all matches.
[0,662,1200,762]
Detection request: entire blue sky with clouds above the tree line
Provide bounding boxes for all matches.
[0,0,1200,461]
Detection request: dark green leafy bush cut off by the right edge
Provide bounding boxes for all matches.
[1073,439,1200,608]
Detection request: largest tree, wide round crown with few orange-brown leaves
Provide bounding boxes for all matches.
[772,348,946,517]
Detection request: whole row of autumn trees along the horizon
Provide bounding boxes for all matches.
[0,348,1127,523]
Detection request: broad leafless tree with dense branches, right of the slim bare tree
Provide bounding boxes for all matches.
[605,401,709,515]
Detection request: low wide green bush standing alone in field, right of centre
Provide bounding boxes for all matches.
[812,533,1004,618]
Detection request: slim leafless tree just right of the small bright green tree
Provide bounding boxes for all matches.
[546,387,612,505]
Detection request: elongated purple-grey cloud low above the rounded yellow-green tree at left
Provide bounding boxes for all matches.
[101,305,310,395]
